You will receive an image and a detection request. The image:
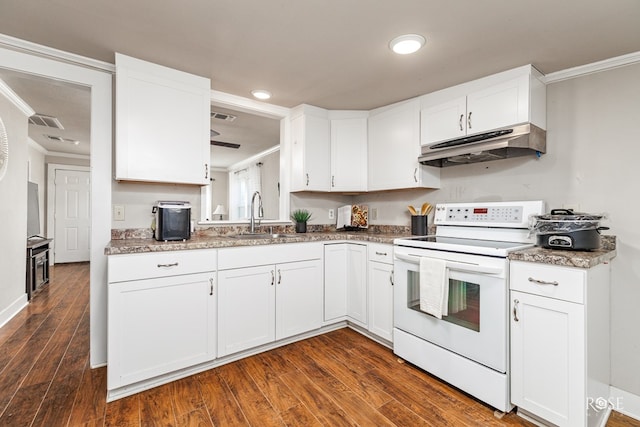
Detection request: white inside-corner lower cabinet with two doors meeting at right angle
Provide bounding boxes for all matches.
[324,243,367,328]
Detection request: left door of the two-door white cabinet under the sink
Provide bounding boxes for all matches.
[218,266,276,357]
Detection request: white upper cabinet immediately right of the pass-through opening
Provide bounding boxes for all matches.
[291,105,331,191]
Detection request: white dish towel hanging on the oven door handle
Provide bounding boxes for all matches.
[420,257,449,319]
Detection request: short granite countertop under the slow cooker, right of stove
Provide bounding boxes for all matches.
[509,236,617,268]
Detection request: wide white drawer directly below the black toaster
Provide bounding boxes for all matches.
[107,249,217,283]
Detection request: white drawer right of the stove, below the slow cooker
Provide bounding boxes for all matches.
[509,261,587,304]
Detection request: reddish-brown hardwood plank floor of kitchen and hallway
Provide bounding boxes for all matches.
[0,263,640,427]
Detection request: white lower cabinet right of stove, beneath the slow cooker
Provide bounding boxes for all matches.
[510,261,609,426]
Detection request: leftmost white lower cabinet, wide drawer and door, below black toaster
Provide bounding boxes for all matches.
[107,250,216,390]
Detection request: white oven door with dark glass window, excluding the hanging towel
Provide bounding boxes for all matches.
[394,246,508,373]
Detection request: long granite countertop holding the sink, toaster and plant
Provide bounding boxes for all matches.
[104,231,409,255]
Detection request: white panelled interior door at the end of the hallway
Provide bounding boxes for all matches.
[54,169,91,263]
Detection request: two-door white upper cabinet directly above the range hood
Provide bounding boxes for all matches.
[421,65,546,145]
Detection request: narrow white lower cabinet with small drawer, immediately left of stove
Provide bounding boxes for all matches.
[367,244,393,341]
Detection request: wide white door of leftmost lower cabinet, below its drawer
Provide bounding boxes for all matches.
[107,273,216,390]
